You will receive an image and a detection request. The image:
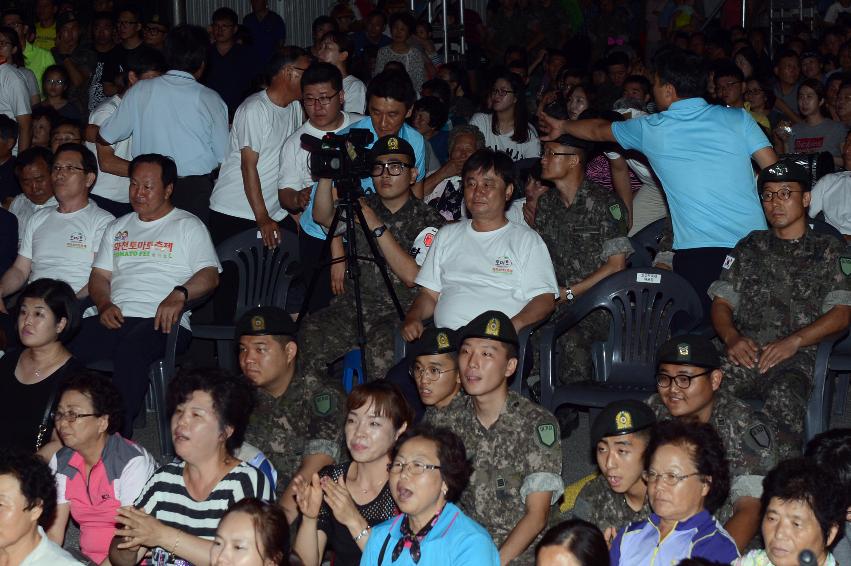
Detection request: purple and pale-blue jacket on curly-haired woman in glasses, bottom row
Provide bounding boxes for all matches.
[609,509,739,566]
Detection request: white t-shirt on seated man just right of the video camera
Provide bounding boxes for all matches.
[416,220,558,329]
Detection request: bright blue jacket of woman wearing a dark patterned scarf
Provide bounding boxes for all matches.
[360,503,499,566]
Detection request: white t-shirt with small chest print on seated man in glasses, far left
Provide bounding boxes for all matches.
[18,200,115,293]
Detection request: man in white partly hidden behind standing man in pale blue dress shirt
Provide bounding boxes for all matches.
[86,49,166,218]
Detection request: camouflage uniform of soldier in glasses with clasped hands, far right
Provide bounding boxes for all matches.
[708,229,851,457]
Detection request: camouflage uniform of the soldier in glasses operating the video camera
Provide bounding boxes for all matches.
[299,193,444,379]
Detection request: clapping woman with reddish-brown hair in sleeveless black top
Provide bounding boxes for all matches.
[294,380,413,566]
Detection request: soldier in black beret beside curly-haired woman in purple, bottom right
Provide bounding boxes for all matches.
[561,399,656,540]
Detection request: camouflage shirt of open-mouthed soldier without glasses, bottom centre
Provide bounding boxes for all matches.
[441,391,563,566]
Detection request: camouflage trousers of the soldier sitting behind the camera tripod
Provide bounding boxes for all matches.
[298,295,400,381]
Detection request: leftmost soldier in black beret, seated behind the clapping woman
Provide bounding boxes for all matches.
[236,307,345,521]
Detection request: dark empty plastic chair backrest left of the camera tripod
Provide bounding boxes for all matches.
[216,228,299,320]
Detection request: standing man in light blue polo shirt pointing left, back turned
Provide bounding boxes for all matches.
[546,49,777,315]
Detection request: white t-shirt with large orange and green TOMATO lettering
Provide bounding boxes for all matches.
[94,208,222,329]
